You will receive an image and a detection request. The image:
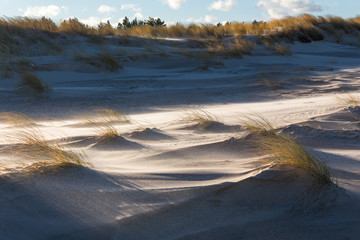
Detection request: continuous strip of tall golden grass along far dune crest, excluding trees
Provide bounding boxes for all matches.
[0,14,360,44]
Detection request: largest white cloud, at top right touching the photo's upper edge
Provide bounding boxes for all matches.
[257,0,322,18]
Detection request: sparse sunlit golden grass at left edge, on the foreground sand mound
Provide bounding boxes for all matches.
[0,113,90,171]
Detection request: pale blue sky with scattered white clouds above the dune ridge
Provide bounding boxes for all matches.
[0,0,360,26]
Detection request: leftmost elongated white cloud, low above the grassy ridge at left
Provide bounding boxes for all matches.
[19,5,67,17]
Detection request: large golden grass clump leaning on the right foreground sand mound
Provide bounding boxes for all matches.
[259,134,332,185]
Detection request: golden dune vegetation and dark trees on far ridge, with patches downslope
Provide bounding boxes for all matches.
[0,14,360,59]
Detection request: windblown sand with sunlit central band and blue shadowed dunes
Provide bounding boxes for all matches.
[0,37,360,239]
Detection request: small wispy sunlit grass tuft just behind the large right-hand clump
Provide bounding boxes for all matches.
[242,114,276,136]
